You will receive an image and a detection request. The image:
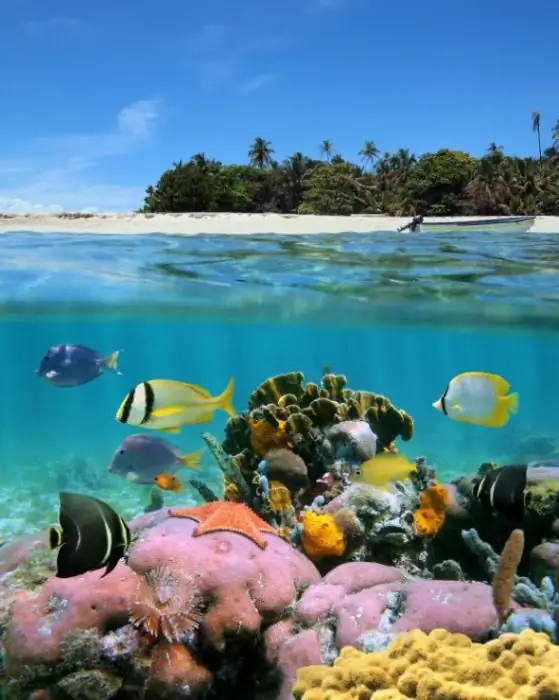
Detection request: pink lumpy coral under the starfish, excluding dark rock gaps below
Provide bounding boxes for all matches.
[6,511,320,698]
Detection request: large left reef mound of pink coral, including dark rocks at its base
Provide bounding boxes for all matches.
[2,511,320,700]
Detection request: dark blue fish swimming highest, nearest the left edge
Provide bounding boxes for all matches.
[35,343,121,388]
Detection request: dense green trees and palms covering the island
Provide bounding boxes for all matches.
[141,112,559,216]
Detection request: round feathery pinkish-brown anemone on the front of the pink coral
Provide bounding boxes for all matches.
[130,567,202,643]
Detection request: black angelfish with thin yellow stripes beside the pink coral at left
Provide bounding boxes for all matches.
[48,491,130,578]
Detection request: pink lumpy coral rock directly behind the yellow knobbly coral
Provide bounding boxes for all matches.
[265,562,497,700]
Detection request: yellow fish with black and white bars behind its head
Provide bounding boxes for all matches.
[115,377,237,433]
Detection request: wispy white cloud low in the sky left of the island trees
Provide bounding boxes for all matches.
[0,100,160,213]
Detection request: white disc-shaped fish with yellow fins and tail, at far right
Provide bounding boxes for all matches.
[433,372,518,428]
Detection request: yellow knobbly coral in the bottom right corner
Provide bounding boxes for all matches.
[293,629,559,700]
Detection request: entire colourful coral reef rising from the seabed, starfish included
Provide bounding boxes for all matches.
[7,372,559,700]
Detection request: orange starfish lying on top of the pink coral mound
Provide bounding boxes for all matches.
[169,501,278,549]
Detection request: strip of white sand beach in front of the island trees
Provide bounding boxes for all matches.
[0,214,559,236]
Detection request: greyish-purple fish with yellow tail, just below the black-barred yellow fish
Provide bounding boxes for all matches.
[109,434,204,484]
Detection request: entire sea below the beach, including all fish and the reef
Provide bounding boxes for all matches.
[0,232,559,700]
